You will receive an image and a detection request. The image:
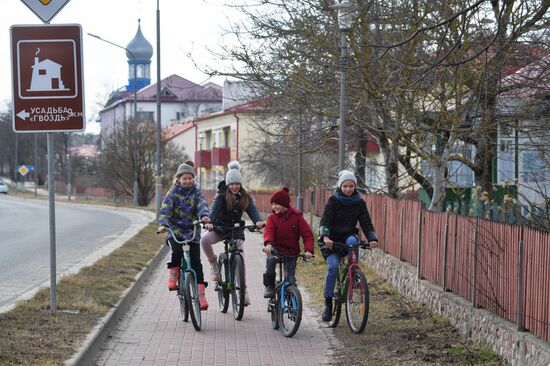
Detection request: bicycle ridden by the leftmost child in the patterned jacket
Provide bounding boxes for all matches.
[157,221,202,331]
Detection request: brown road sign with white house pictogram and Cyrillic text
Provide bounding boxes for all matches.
[10,24,85,132]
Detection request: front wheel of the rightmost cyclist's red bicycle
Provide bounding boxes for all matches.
[345,268,369,334]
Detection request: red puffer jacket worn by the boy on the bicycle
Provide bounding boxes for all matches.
[264,207,314,257]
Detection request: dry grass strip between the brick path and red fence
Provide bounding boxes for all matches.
[297,255,504,365]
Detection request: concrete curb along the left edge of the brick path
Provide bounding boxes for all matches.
[63,245,168,366]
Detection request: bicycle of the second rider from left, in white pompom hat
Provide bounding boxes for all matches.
[213,222,264,320]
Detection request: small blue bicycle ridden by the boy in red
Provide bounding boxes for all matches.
[267,249,314,337]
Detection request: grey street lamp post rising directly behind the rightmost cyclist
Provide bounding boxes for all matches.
[333,1,353,170]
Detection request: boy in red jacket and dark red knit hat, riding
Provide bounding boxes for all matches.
[264,186,314,298]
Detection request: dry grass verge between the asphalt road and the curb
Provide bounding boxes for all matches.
[0,224,163,365]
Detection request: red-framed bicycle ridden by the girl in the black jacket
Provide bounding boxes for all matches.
[328,241,370,334]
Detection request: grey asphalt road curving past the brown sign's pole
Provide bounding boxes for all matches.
[0,195,154,312]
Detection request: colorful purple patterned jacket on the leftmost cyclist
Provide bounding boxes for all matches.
[159,182,208,242]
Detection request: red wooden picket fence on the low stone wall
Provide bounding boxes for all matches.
[365,195,550,342]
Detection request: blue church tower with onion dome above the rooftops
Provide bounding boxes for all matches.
[126,19,153,93]
